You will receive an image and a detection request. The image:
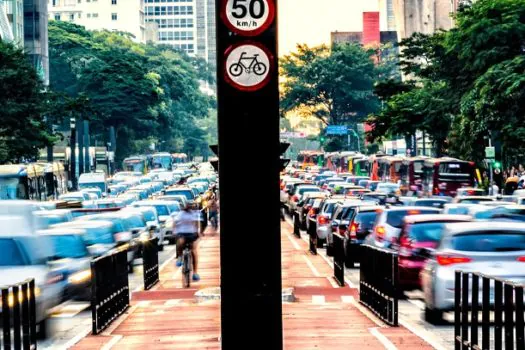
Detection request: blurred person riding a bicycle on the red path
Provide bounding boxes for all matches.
[173,203,200,281]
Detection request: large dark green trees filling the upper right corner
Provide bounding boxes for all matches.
[369,0,525,161]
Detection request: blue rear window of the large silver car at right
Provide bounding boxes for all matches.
[451,231,525,252]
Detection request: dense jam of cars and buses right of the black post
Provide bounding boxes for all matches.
[280,151,525,330]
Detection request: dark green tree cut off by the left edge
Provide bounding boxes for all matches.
[0,41,54,163]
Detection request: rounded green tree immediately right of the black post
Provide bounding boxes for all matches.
[281,44,380,125]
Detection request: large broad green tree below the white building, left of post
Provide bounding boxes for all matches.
[49,21,215,161]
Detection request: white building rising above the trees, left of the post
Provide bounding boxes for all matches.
[48,0,146,43]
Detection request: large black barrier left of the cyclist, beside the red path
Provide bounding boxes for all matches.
[91,249,129,334]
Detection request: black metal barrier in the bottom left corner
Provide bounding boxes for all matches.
[0,279,36,350]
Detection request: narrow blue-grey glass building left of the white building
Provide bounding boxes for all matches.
[23,0,49,86]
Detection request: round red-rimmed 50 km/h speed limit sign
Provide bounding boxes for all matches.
[221,0,275,36]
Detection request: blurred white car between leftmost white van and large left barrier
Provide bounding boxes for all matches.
[37,228,92,301]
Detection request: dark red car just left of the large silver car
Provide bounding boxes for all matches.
[391,214,472,292]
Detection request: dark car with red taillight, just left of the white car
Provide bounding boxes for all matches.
[343,204,385,268]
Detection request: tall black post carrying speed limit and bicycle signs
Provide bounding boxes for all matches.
[216,0,285,350]
